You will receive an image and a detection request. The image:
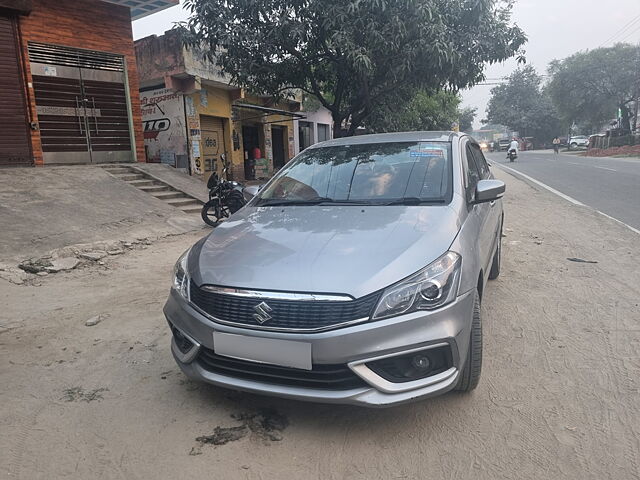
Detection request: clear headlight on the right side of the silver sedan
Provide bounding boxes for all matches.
[373,252,462,320]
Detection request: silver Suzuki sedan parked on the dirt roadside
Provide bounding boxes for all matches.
[164,132,505,407]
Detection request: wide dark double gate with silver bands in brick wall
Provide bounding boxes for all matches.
[29,43,134,163]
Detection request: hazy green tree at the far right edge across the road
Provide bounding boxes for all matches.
[549,43,640,130]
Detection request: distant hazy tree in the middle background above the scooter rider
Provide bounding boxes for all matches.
[487,65,563,141]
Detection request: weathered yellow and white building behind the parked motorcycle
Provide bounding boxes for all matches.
[135,31,304,180]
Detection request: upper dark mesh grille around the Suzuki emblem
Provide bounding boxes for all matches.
[190,283,380,331]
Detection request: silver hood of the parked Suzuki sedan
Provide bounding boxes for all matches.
[189,205,460,298]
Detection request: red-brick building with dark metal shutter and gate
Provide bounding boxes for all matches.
[0,0,178,166]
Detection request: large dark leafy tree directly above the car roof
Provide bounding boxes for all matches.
[180,0,526,134]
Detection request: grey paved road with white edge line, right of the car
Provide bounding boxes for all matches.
[488,151,640,229]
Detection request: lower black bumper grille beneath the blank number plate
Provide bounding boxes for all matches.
[197,347,367,390]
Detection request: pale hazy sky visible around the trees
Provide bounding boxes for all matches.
[133,0,640,127]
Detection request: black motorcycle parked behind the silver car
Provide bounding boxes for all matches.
[201,167,260,227]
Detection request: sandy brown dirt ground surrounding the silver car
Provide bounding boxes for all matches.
[0,169,640,480]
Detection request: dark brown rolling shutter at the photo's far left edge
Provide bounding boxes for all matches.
[0,16,33,166]
